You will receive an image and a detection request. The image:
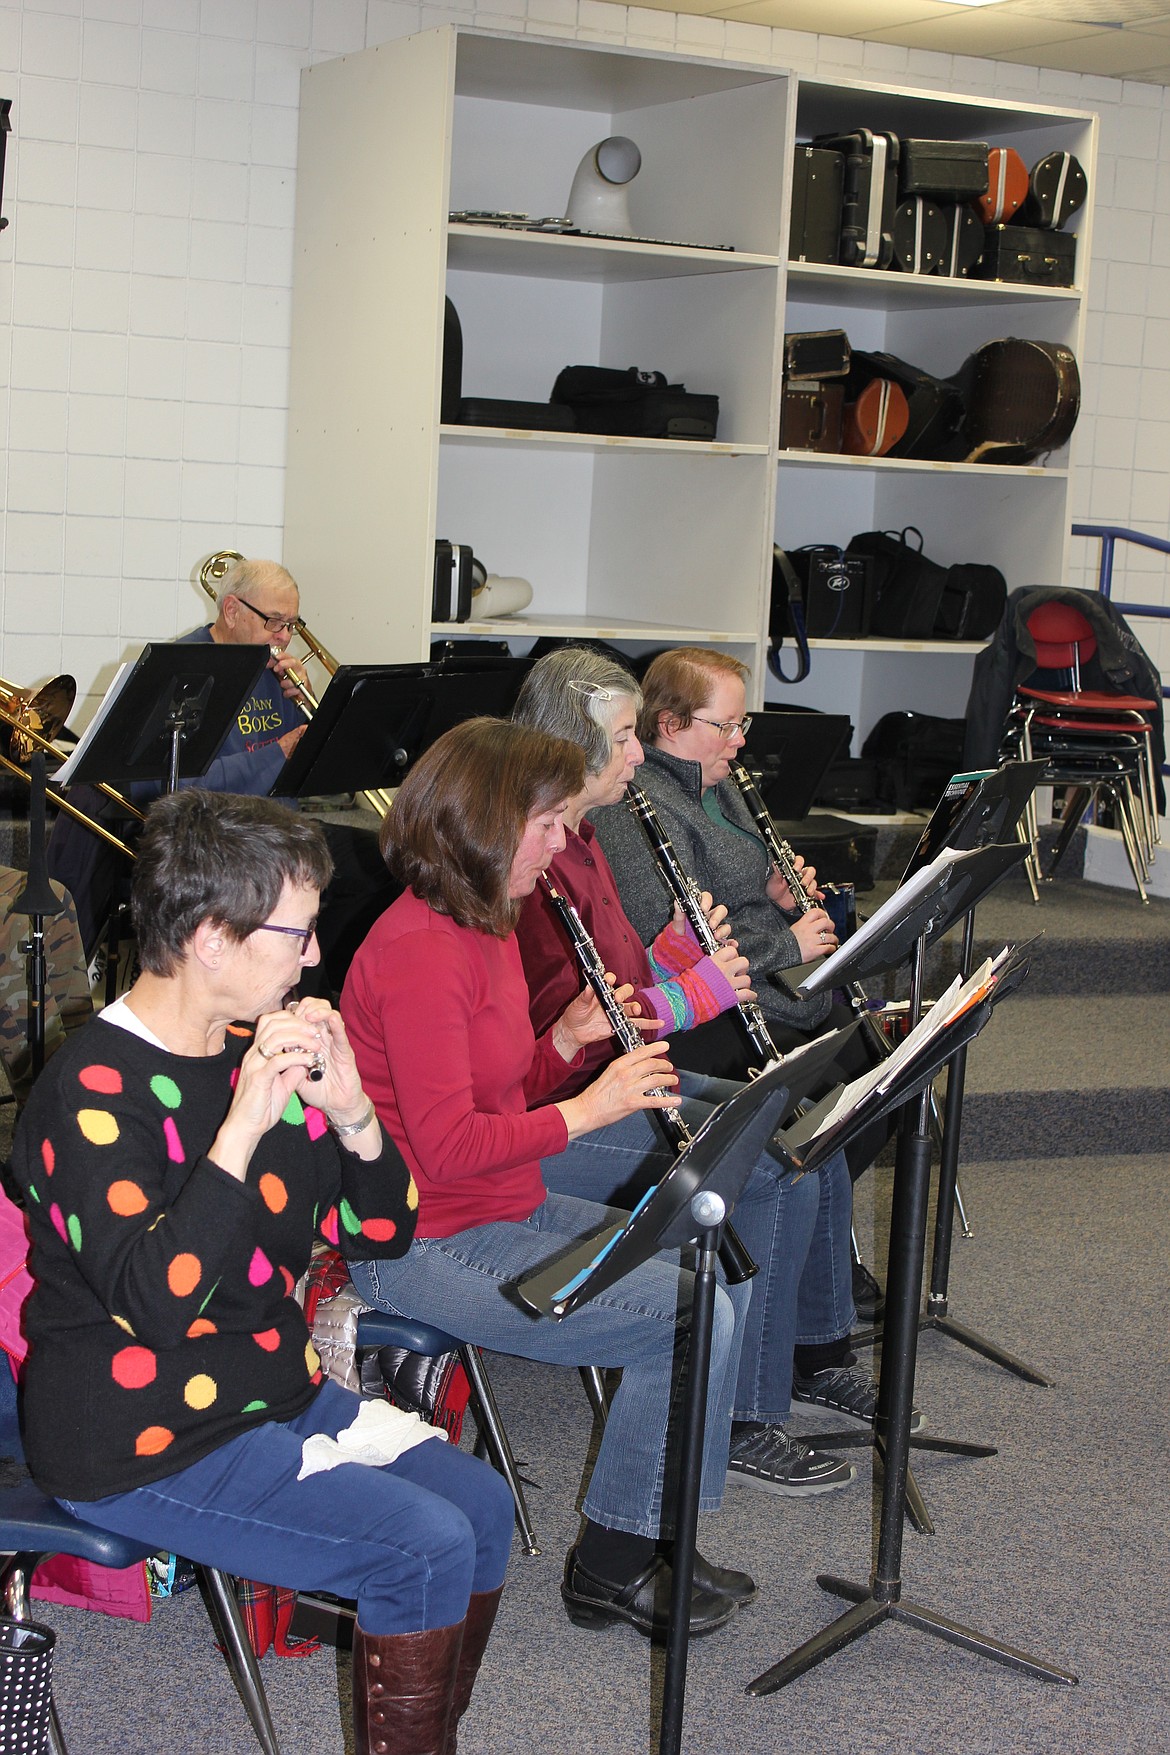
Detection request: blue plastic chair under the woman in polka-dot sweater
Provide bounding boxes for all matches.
[0,1481,281,1755]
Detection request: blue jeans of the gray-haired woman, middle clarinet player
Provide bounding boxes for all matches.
[542,1072,854,1423]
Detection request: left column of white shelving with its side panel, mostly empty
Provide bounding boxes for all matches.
[286,26,791,674]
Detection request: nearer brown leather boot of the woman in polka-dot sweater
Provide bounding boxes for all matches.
[353,1622,463,1755]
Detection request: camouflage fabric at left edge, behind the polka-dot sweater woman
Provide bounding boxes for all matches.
[0,865,93,1104]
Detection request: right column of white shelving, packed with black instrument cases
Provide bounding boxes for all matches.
[767,79,1096,748]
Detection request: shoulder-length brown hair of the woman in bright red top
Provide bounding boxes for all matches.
[381,718,584,939]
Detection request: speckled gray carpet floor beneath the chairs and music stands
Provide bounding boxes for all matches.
[9,870,1170,1755]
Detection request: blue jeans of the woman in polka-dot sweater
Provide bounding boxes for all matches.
[60,1383,512,1634]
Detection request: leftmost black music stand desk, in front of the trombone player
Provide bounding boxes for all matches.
[54,641,270,792]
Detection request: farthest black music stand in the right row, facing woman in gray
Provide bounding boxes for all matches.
[905,762,1052,1390]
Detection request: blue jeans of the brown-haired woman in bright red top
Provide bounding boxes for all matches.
[349,1193,749,1536]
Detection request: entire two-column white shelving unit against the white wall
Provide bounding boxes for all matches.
[284,25,1095,735]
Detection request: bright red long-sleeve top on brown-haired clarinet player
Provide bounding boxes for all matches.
[340,890,568,1237]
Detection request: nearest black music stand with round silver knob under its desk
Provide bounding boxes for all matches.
[516,1064,791,1755]
